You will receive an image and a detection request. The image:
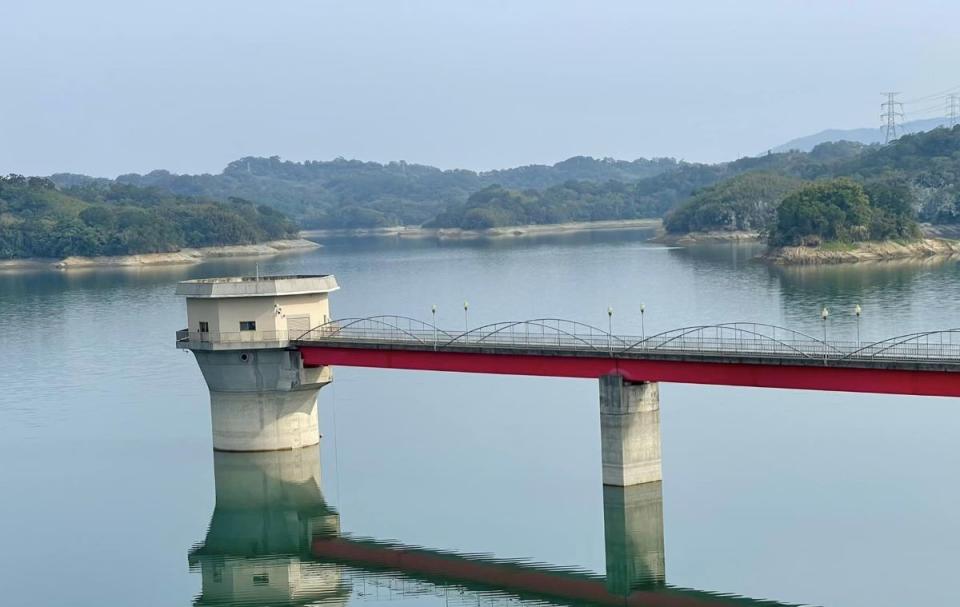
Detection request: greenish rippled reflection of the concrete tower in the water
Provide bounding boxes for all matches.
[189,446,350,605]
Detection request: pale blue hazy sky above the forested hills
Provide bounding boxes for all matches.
[0,0,960,176]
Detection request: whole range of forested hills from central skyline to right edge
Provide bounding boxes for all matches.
[43,127,960,232]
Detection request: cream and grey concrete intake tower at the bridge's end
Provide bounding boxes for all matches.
[177,276,339,451]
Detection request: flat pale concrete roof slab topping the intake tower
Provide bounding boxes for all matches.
[177,274,340,299]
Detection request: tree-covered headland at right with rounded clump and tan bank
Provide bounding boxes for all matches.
[663,173,960,265]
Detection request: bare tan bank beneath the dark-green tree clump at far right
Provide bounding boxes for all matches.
[759,238,960,266]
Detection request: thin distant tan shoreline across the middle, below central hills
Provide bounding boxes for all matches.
[300,219,662,240]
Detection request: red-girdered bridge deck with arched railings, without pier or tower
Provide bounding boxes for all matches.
[289,316,960,396]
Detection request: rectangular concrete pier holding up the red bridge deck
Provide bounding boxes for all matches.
[600,375,663,487]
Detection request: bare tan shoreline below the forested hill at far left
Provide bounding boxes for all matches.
[0,238,322,271]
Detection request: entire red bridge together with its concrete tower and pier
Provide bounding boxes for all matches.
[177,275,960,487]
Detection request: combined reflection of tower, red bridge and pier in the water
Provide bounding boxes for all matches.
[188,447,804,607]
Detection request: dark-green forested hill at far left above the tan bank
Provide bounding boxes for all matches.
[0,175,297,259]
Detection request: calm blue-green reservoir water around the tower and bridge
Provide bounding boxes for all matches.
[0,231,960,607]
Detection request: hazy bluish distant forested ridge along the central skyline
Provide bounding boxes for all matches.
[51,156,677,228]
